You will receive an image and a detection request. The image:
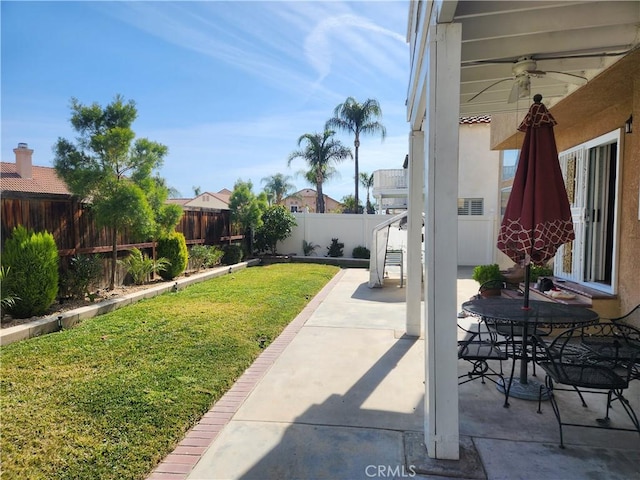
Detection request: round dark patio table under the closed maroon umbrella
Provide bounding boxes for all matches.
[462,297,600,400]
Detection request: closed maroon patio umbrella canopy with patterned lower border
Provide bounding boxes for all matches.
[497,94,575,265]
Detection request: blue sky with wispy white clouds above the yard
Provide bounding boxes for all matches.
[1,0,409,200]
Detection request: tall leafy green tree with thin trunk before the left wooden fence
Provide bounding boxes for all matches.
[54,95,176,290]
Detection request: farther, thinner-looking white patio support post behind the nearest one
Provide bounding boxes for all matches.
[406,131,424,337]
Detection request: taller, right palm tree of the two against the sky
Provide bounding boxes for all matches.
[325,97,387,213]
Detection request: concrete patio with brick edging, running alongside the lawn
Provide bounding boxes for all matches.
[148,268,640,480]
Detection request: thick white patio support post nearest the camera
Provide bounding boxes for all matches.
[424,23,461,460]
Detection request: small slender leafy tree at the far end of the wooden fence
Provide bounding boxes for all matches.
[229,180,268,252]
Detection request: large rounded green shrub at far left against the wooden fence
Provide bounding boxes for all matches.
[2,225,59,318]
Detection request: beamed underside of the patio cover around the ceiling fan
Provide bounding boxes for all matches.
[450,0,640,116]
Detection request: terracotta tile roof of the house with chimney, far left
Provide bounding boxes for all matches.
[0,162,71,195]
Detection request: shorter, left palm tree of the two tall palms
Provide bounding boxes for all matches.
[287,129,353,213]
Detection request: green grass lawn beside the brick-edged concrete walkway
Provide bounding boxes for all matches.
[0,264,338,480]
